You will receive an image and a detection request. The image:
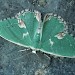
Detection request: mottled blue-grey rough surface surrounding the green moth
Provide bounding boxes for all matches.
[0,0,75,75]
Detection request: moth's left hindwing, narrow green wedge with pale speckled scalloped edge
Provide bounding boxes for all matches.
[18,10,41,40]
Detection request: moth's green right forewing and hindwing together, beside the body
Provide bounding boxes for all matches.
[41,16,75,57]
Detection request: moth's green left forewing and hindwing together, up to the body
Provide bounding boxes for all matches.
[0,11,38,47]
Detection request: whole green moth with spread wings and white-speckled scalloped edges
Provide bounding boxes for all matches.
[0,10,75,57]
